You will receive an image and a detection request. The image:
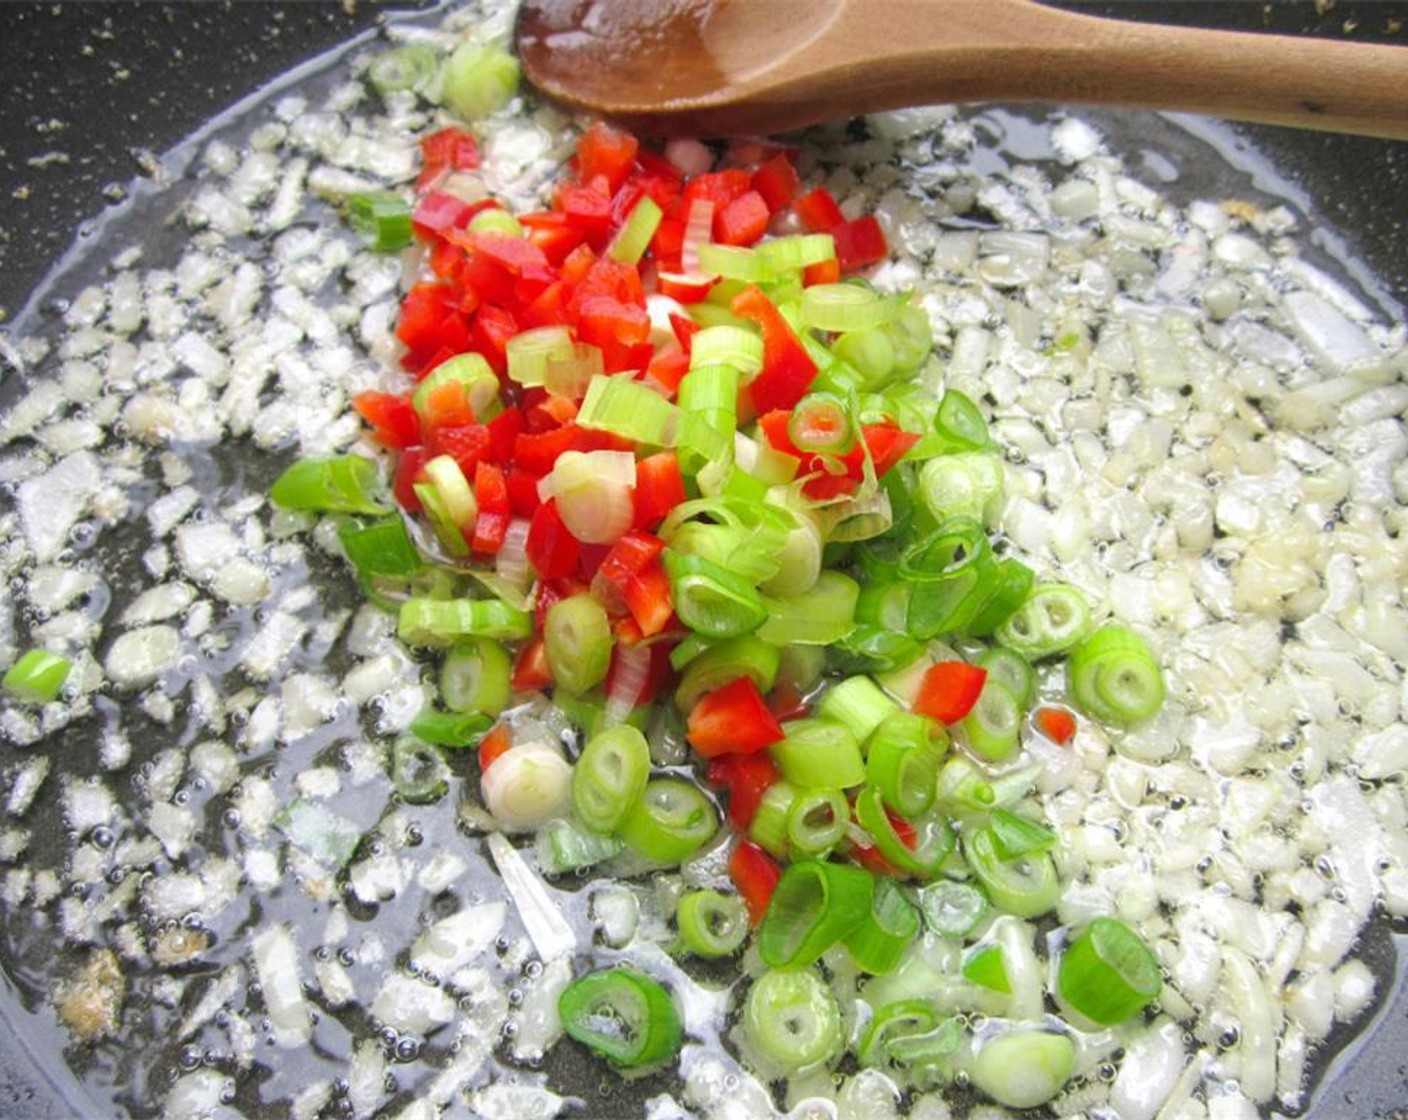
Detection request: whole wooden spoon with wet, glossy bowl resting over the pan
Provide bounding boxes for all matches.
[515,0,1408,139]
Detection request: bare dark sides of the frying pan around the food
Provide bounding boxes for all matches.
[0,0,1408,1120]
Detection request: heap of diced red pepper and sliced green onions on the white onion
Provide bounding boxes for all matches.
[272,123,1164,1107]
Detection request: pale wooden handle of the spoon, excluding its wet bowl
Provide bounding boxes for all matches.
[732,0,1408,139]
